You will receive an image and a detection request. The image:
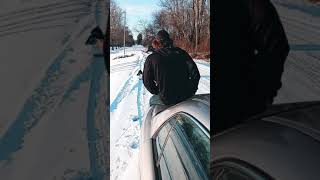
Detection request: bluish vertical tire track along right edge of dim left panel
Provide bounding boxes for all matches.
[83,1,110,180]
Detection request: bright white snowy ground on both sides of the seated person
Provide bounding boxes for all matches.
[110,46,210,180]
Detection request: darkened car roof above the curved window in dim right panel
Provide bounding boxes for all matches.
[211,102,320,180]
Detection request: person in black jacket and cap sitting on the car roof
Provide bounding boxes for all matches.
[142,30,200,105]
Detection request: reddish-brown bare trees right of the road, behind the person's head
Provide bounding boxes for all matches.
[139,0,210,53]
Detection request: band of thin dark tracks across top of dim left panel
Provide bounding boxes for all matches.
[0,1,92,37]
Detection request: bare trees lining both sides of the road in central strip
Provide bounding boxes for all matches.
[110,0,210,54]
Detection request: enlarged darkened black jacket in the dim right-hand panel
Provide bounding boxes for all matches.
[211,0,289,131]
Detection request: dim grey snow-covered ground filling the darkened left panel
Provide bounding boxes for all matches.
[0,0,109,180]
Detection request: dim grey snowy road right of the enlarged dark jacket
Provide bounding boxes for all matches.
[273,0,320,103]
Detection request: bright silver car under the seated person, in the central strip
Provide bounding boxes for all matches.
[139,94,210,180]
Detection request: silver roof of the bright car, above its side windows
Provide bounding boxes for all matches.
[142,94,210,142]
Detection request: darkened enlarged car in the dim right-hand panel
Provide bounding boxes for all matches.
[210,102,320,180]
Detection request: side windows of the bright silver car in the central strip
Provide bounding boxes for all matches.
[155,113,210,180]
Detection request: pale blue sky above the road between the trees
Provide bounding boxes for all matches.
[115,0,160,39]
